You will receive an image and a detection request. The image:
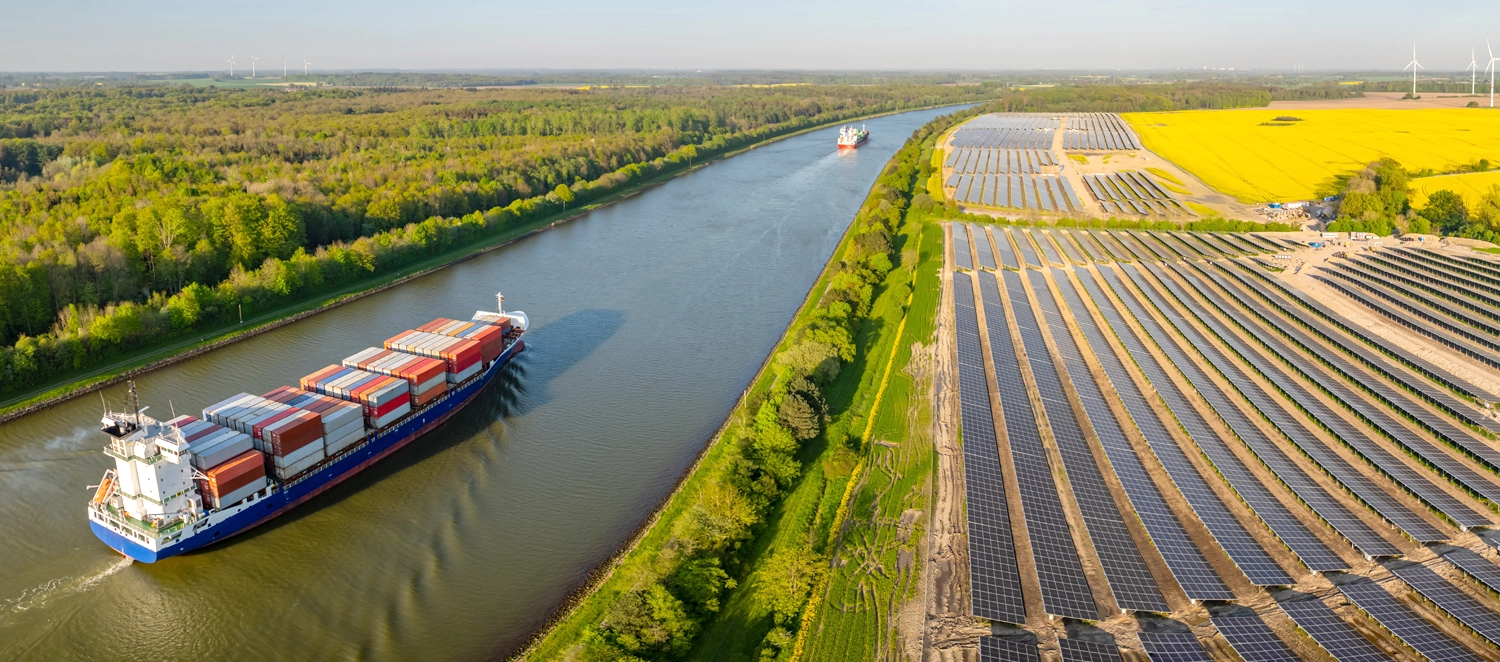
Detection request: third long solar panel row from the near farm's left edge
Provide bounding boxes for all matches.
[1007,268,1170,612]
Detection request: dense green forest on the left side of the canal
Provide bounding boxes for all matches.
[0,86,995,392]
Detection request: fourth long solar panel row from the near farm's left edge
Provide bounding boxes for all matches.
[1056,270,1235,600]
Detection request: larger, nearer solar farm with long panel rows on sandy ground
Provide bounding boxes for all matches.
[935,225,1500,662]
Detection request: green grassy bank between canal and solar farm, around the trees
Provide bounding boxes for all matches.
[525,105,972,660]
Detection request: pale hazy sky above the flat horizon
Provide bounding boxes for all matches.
[0,0,1500,74]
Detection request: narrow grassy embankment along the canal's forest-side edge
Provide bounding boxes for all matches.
[0,108,966,422]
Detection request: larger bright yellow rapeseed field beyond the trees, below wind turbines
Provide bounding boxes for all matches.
[1124,108,1500,203]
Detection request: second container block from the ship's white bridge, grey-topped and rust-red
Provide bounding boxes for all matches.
[203,393,326,479]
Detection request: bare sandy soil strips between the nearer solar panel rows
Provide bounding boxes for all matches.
[921,225,1500,662]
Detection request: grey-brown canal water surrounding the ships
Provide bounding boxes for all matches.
[0,110,951,660]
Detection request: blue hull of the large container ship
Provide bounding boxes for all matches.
[89,339,527,563]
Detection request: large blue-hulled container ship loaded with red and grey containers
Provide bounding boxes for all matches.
[89,294,528,563]
